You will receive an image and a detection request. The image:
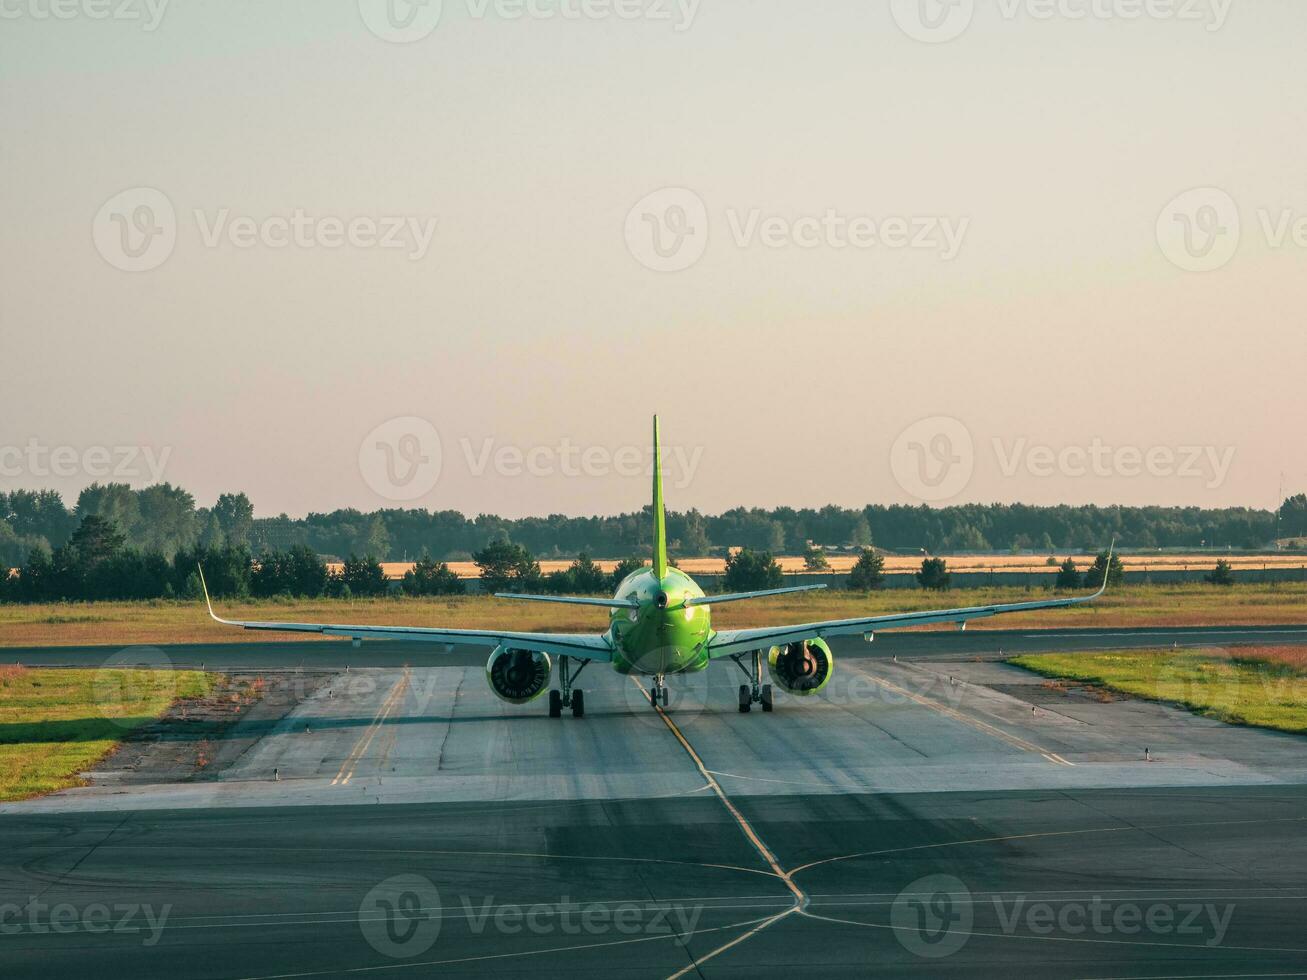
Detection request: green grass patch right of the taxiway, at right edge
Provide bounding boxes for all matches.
[1009,648,1307,734]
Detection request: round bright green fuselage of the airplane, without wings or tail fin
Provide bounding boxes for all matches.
[608,568,712,676]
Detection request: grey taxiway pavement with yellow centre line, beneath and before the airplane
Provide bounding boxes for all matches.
[0,632,1307,977]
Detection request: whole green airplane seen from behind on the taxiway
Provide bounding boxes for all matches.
[200,416,1115,717]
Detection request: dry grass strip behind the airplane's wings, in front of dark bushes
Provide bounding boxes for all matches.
[0,583,1307,647]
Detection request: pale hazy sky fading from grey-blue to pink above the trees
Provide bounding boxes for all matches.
[0,0,1307,516]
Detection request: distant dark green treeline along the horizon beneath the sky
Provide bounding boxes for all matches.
[0,483,1307,567]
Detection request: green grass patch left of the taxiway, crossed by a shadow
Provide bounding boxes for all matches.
[0,666,213,801]
